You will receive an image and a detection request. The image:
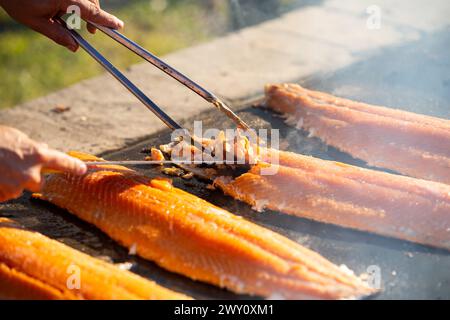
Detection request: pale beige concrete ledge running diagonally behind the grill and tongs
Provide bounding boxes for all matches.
[0,0,450,153]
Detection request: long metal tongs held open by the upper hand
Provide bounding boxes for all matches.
[62,21,250,130]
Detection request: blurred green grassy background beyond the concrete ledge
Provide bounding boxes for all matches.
[0,0,312,108]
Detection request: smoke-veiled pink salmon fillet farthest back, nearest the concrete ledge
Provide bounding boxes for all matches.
[266,84,450,184]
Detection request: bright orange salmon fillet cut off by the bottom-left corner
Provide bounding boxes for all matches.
[0,218,188,300]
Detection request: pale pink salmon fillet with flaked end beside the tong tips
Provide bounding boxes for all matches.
[214,150,450,249]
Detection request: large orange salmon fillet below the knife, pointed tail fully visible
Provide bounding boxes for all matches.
[33,153,375,299]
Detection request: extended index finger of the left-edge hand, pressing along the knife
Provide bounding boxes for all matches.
[41,149,87,175]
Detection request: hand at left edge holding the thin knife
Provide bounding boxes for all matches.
[0,126,86,201]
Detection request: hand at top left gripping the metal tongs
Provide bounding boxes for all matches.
[0,0,123,52]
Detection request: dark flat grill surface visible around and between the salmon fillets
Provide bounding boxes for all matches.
[0,0,450,299]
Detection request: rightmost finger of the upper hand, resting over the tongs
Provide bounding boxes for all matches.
[61,0,123,29]
